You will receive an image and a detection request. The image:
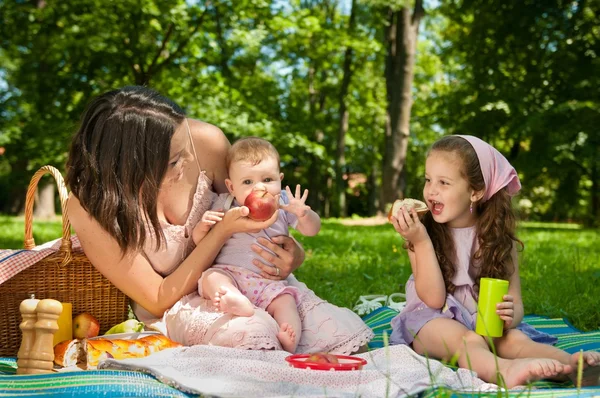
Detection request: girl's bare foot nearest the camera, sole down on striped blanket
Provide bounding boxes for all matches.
[500,358,573,388]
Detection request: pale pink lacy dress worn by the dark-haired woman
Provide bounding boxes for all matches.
[134,172,373,354]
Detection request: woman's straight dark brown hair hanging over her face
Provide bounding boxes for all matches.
[67,86,185,254]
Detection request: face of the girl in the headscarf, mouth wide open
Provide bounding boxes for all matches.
[423,151,480,228]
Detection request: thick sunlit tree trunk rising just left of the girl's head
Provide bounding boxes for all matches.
[379,0,425,211]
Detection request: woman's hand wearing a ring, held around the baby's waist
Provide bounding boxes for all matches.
[252,236,304,281]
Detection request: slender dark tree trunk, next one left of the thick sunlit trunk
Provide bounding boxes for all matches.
[335,0,356,217]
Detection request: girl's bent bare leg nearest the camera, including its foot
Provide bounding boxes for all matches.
[413,318,571,388]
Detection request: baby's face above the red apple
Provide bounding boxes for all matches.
[226,157,283,205]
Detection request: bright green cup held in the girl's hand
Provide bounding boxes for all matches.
[475,278,508,337]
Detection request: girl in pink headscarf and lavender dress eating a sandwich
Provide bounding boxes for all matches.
[390,135,600,388]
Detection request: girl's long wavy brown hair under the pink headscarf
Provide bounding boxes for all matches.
[408,135,523,294]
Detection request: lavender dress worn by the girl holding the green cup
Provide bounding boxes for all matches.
[390,227,557,345]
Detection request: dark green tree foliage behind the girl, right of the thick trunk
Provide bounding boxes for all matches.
[439,0,600,225]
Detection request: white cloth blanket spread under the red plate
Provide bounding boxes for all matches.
[99,345,498,397]
